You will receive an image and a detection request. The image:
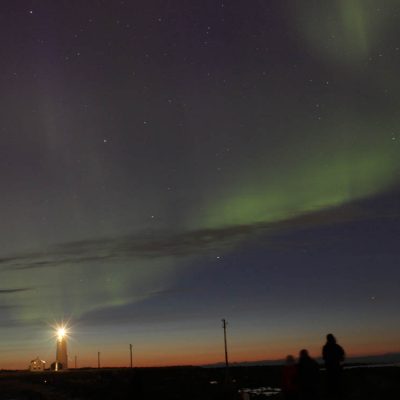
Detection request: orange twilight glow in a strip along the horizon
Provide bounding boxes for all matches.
[0,332,400,369]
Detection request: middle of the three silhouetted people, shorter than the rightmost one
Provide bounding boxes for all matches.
[298,349,319,400]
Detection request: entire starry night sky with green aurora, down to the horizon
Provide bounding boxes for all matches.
[0,0,400,368]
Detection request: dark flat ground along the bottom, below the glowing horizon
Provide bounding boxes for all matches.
[0,366,400,400]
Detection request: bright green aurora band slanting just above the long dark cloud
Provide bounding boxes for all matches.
[200,134,400,228]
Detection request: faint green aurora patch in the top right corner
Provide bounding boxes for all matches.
[293,0,398,64]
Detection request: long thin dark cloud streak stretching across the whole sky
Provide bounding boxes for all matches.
[0,194,400,272]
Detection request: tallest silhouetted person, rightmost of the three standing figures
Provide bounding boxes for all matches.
[322,333,345,394]
